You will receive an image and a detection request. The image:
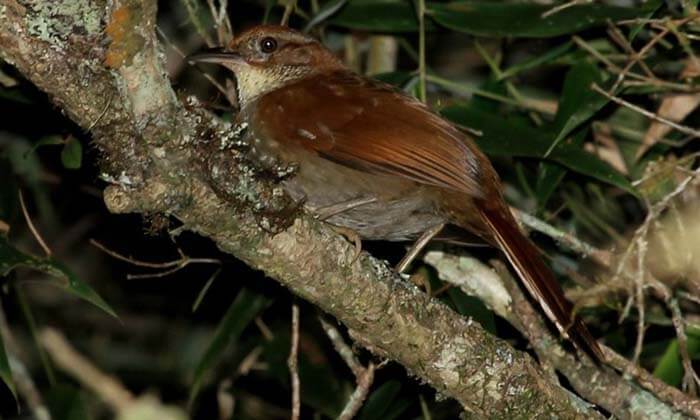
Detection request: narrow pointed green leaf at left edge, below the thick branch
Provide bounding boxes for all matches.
[0,236,118,318]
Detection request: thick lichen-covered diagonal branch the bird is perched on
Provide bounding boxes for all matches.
[0,0,616,418]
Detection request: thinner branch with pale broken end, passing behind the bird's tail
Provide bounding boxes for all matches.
[425,251,700,419]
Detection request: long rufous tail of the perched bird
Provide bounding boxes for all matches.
[481,206,604,361]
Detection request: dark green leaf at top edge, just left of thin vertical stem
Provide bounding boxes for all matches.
[329,0,418,32]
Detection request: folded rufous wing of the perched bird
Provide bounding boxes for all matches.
[254,72,481,196]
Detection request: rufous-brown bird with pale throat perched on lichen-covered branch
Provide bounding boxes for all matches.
[190,26,602,360]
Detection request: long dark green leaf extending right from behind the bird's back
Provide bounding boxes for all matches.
[441,105,636,194]
